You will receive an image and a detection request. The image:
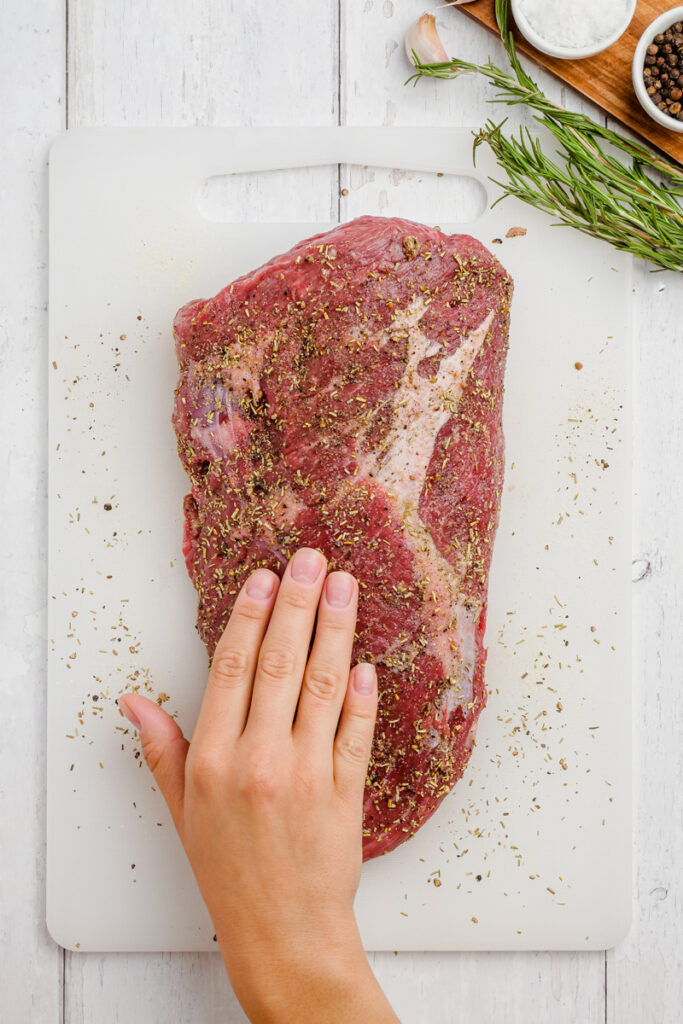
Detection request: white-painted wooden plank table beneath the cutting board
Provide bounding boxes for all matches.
[0,0,683,1024]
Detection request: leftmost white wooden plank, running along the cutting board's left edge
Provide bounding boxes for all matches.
[0,0,65,1024]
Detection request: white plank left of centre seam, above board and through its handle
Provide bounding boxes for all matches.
[67,0,339,220]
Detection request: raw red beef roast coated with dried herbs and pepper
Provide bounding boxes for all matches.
[173,217,512,859]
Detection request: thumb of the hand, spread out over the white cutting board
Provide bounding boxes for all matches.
[119,693,189,838]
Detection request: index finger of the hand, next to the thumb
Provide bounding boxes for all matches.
[193,568,280,745]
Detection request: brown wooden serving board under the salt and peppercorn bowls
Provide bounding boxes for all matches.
[460,0,683,164]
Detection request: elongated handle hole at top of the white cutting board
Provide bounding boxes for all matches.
[197,164,486,225]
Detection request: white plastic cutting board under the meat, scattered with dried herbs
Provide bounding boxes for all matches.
[47,128,631,950]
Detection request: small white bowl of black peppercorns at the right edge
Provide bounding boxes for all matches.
[633,7,683,132]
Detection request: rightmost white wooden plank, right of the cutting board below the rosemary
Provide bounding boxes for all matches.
[607,258,683,1024]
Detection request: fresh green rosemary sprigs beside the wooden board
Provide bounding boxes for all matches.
[409,0,683,271]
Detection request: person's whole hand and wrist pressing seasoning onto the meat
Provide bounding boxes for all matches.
[119,548,397,1024]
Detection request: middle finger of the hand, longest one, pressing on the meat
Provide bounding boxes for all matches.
[245,548,327,733]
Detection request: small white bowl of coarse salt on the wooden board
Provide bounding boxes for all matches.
[511,0,637,60]
